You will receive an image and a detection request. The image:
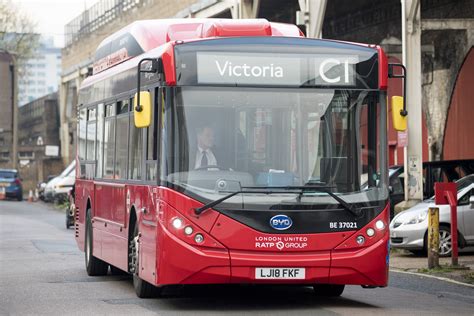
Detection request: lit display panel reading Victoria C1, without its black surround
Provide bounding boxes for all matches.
[196,52,358,86]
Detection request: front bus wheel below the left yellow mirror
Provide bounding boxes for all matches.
[128,221,161,298]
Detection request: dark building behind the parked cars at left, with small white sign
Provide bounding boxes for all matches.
[18,93,64,192]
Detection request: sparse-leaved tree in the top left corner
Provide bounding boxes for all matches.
[0,0,39,59]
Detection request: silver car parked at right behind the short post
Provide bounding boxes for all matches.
[390,175,474,256]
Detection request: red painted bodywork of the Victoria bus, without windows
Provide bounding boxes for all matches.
[75,19,389,286]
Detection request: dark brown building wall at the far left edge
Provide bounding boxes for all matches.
[0,51,17,168]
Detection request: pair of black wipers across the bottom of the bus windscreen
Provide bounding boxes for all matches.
[194,185,360,216]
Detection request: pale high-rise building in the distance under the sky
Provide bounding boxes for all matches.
[18,37,61,106]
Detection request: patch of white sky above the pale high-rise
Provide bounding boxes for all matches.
[11,0,98,47]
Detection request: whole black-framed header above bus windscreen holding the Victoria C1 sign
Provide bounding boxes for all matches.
[175,38,379,89]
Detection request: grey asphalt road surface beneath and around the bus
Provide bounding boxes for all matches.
[0,201,474,315]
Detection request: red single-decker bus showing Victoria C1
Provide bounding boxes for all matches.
[75,19,404,297]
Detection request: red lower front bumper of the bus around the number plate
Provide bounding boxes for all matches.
[155,228,388,287]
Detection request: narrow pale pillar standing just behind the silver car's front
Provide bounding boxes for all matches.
[401,0,423,207]
